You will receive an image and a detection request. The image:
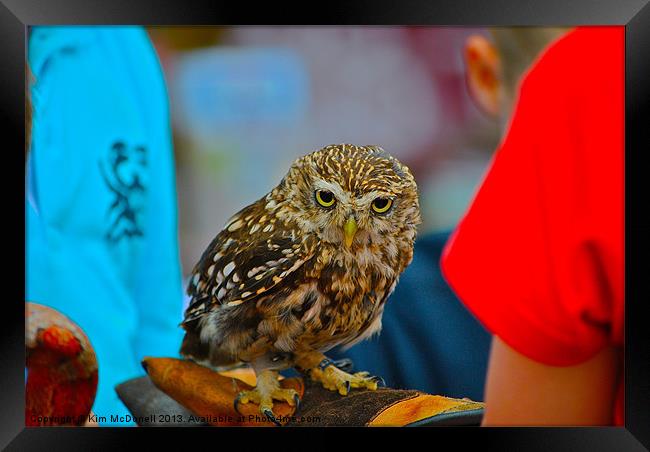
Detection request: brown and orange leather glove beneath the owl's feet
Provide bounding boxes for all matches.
[116,358,483,427]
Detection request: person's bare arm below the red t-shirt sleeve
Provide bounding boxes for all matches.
[482,336,620,426]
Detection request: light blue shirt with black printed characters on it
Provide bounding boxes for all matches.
[25,27,182,425]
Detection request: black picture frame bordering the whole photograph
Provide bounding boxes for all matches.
[0,0,650,451]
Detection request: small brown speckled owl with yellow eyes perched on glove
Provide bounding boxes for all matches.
[181,144,421,421]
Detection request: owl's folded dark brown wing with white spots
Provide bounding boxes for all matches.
[182,200,316,324]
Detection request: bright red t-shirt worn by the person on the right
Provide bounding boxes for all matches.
[441,27,625,425]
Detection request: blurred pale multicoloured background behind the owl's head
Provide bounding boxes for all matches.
[148,26,499,292]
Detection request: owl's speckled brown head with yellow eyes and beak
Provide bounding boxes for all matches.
[274,144,421,249]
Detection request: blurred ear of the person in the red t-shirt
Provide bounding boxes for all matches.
[464,35,501,117]
